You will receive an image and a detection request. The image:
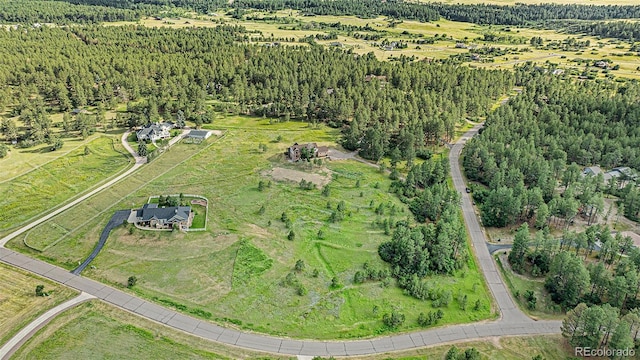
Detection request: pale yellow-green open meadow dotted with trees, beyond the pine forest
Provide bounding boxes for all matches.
[121,10,640,79]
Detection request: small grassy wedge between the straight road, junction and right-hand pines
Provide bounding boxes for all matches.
[495,255,564,320]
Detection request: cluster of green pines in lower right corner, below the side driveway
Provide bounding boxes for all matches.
[508,224,640,349]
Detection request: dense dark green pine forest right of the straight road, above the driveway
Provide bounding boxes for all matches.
[463,69,640,228]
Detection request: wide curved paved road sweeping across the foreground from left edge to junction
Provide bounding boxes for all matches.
[0,248,560,356]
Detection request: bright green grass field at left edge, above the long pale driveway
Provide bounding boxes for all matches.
[0,137,129,238]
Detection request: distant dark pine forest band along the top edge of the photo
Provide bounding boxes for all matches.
[5,0,640,25]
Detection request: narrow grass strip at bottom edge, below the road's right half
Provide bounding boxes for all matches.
[352,335,573,360]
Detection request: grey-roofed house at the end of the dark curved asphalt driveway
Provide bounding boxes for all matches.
[134,204,193,230]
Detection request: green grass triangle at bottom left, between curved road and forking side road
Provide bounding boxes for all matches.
[12,301,278,360]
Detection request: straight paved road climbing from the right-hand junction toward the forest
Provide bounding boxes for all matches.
[449,124,532,324]
